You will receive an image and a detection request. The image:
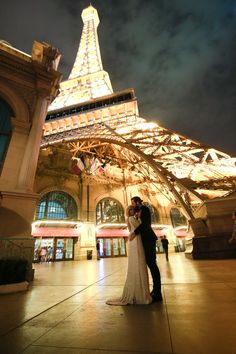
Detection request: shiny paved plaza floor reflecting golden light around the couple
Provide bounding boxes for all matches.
[0,253,236,354]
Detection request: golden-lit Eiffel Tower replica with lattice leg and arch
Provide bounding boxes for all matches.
[41,5,236,258]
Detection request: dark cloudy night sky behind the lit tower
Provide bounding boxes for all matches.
[0,0,236,156]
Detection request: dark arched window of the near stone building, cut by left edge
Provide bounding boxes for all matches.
[0,98,14,171]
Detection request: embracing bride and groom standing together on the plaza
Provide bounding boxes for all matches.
[106,197,162,305]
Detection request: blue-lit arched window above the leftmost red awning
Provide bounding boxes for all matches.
[35,192,77,220]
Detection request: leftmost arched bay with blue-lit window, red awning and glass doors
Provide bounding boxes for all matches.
[33,191,78,262]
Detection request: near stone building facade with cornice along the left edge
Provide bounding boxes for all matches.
[0,41,61,278]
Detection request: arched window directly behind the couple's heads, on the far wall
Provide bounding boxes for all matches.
[96,198,125,224]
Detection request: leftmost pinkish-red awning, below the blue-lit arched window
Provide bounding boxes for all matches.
[32,227,80,237]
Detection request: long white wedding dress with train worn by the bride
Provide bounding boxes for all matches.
[106,216,152,306]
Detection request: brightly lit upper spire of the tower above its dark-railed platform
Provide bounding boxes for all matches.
[49,4,113,111]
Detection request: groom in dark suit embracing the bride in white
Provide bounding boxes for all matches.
[131,197,162,302]
